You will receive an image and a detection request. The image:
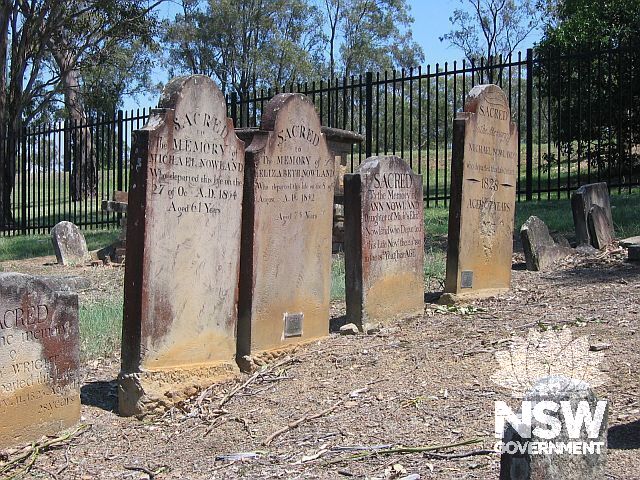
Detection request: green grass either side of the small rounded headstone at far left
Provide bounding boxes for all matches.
[0,230,119,261]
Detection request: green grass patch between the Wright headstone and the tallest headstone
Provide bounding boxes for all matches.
[79,296,123,359]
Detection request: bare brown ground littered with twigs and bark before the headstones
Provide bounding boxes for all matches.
[4,248,640,480]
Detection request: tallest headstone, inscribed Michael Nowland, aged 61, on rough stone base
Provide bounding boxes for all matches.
[119,75,244,415]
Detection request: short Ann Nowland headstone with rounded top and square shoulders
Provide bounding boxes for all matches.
[344,157,424,331]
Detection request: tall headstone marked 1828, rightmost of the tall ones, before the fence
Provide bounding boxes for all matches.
[444,85,518,297]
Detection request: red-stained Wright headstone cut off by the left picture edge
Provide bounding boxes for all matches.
[0,273,81,448]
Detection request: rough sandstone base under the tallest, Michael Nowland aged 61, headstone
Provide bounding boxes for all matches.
[118,362,240,417]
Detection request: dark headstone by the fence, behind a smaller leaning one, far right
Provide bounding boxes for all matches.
[571,182,614,248]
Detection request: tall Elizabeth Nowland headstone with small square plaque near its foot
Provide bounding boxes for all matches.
[238,94,335,357]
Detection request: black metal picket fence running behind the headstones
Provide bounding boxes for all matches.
[3,48,640,235]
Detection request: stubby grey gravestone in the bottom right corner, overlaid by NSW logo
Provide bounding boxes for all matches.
[500,376,608,480]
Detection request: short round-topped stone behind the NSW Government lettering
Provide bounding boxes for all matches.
[500,377,608,480]
